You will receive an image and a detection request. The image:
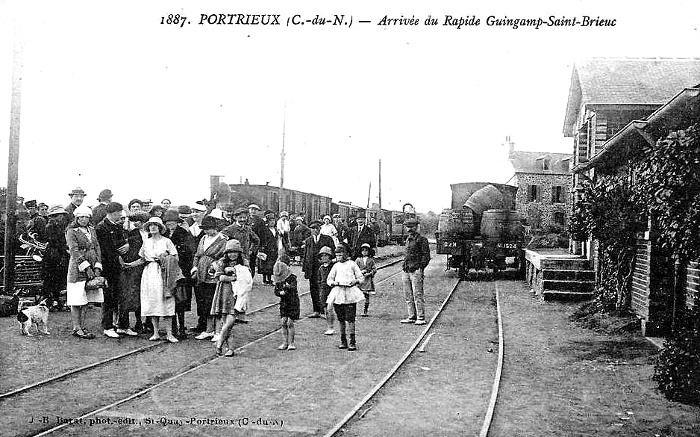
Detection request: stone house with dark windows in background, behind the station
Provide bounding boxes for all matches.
[509,143,571,230]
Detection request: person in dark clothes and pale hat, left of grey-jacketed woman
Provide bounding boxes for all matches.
[42,205,68,309]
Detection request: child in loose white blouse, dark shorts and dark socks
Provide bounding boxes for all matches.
[327,245,364,351]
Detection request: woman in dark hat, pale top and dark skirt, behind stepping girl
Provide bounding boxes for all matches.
[190,216,226,340]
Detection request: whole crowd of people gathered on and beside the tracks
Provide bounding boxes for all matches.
[15,188,430,356]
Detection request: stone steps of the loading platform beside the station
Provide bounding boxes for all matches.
[525,250,595,301]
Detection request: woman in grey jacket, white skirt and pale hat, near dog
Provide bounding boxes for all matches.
[66,205,103,338]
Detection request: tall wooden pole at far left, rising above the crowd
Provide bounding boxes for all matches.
[3,24,22,294]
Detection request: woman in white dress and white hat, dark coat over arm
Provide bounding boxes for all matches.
[139,217,183,343]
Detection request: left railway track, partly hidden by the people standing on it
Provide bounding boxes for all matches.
[0,254,402,436]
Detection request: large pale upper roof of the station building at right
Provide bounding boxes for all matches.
[564,58,700,136]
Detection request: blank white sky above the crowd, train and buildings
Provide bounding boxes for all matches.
[0,0,700,212]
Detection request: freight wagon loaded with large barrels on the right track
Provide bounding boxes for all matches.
[435,182,524,276]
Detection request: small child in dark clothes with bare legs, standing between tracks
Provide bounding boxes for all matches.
[272,253,299,351]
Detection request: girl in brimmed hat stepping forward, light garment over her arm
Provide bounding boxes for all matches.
[211,240,253,357]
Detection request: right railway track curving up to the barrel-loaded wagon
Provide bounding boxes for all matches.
[324,279,505,437]
